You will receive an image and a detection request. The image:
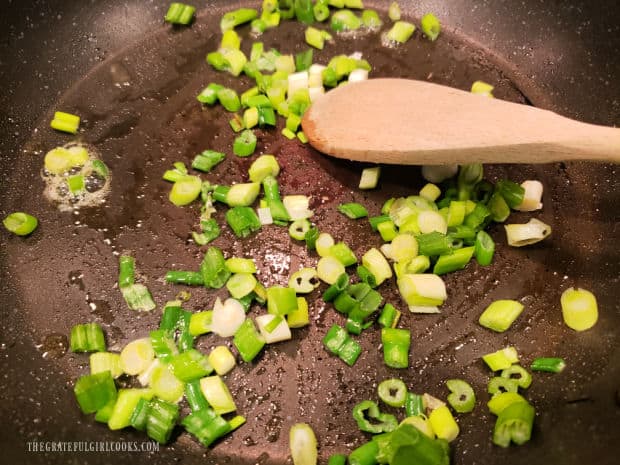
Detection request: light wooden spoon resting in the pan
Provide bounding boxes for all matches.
[302,79,620,165]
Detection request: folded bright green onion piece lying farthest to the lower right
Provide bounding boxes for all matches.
[493,402,536,447]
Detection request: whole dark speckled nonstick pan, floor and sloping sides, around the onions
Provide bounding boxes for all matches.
[0,1,620,465]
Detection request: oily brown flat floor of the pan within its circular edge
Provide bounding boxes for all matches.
[5,4,620,464]
